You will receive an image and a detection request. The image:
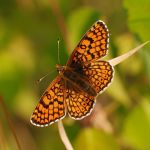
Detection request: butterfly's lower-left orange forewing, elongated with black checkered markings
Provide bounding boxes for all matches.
[30,76,66,127]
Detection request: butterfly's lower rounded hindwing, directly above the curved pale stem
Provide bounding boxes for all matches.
[66,83,95,120]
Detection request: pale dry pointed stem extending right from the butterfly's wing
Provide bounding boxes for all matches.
[109,41,150,66]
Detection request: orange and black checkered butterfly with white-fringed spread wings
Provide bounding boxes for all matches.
[30,20,114,127]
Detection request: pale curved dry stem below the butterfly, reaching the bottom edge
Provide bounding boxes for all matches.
[58,120,73,150]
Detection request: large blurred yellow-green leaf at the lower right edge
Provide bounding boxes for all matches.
[123,100,150,150]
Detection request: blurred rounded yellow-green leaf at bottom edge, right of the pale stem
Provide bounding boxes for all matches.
[74,128,119,150]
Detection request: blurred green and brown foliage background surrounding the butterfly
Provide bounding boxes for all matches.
[0,0,150,150]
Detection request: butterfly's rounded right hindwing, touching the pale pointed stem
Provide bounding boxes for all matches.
[82,61,114,93]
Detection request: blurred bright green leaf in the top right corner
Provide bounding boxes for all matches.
[124,0,150,41]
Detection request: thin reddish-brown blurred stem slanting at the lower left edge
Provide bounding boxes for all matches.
[0,97,21,150]
